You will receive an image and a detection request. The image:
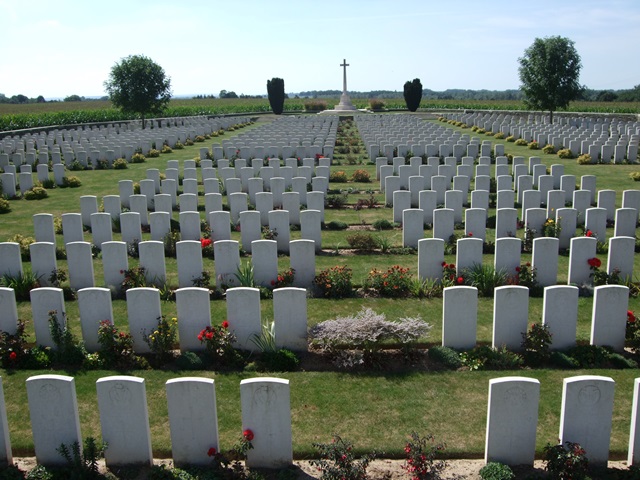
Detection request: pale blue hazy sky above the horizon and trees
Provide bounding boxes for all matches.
[0,0,640,99]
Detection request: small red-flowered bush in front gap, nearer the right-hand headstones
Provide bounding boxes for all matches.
[402,432,447,480]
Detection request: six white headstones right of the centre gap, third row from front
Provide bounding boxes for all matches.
[417,236,635,287]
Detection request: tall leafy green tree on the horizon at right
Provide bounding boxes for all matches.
[518,36,583,122]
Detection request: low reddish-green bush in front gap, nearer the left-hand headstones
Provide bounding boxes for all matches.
[309,434,376,480]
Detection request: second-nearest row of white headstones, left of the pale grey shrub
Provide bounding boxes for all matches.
[0,287,307,353]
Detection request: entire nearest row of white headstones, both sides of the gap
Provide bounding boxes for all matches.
[0,375,640,469]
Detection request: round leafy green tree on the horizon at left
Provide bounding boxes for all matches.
[104,55,171,128]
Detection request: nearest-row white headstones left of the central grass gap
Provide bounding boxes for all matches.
[15,375,293,468]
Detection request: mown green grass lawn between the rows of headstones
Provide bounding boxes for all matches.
[0,111,640,458]
